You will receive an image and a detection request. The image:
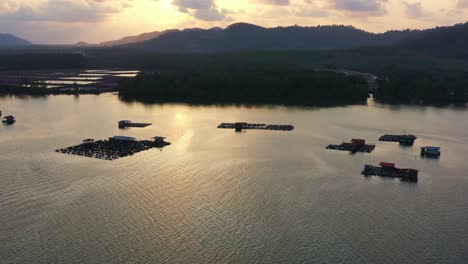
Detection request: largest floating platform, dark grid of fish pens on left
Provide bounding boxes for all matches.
[56,136,171,160]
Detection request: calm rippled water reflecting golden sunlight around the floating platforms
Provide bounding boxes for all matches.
[0,95,468,263]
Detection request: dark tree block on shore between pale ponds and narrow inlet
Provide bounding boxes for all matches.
[119,65,367,105]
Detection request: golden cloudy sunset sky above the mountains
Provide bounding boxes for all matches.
[0,0,468,44]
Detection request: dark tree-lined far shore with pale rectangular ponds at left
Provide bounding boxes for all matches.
[0,60,468,106]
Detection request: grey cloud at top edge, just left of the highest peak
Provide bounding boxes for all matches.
[172,0,226,21]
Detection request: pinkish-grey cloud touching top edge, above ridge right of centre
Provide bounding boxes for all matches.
[330,0,388,15]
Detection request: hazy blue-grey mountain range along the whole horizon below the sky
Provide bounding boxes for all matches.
[0,23,468,55]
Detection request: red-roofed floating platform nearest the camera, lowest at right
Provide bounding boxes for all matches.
[362,162,419,182]
